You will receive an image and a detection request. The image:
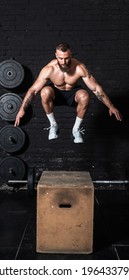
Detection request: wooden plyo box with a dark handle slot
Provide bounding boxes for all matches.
[36,171,94,254]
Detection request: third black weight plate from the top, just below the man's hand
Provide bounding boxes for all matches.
[0,125,25,153]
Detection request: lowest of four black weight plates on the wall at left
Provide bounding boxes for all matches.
[0,157,26,183]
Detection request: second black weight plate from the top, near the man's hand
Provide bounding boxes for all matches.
[0,93,22,121]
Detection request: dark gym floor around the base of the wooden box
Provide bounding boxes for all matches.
[0,186,129,260]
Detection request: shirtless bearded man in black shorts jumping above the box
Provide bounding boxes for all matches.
[14,43,122,143]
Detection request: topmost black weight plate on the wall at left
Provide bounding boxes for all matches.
[0,59,24,88]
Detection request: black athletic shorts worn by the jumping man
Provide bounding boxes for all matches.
[49,84,83,106]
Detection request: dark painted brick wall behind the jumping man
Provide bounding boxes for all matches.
[0,0,129,186]
